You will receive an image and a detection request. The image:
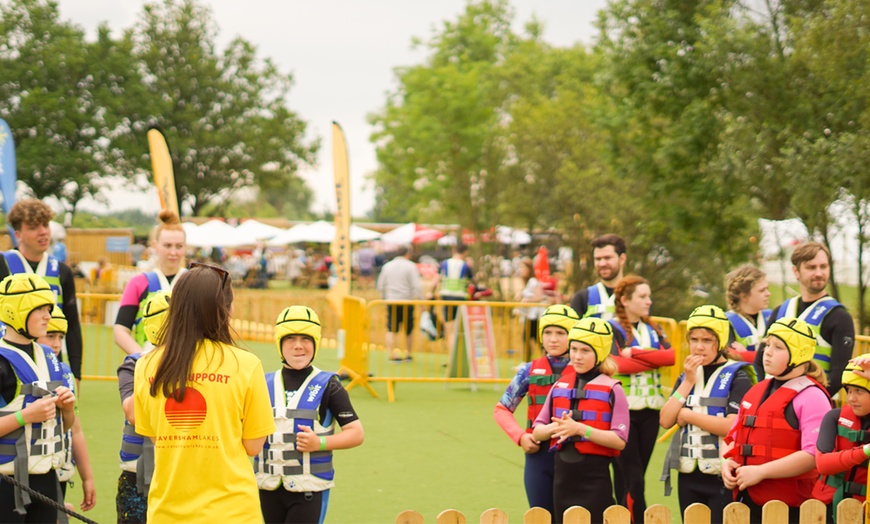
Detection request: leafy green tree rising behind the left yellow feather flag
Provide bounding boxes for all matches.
[127,0,320,215]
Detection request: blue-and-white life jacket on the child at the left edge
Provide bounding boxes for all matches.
[0,340,64,511]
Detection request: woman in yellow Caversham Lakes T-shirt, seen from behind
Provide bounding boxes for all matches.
[134,263,275,523]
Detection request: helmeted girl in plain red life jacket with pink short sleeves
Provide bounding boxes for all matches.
[722,317,831,522]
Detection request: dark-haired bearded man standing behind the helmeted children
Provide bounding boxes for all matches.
[571,234,625,320]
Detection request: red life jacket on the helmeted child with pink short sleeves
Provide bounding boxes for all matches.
[725,375,830,507]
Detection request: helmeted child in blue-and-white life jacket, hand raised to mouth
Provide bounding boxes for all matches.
[659,305,756,522]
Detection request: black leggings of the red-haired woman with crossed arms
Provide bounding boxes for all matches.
[613,408,659,523]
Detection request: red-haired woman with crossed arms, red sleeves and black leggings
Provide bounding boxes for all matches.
[610,275,674,522]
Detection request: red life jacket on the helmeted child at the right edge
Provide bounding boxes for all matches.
[813,404,870,508]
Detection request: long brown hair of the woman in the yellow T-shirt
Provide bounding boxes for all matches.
[151,267,235,402]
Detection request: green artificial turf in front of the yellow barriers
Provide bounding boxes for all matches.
[69,343,678,523]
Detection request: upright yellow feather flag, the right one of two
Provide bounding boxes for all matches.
[326,122,350,318]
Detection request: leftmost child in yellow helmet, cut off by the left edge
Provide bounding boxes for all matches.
[0,273,76,522]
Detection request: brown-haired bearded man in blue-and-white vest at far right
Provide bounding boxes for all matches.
[754,242,855,397]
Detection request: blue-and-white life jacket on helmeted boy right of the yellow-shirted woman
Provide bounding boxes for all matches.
[254,367,335,492]
